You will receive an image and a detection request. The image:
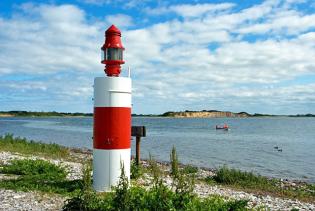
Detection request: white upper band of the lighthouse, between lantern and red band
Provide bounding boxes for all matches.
[94,77,131,108]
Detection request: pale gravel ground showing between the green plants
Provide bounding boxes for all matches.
[0,152,315,211]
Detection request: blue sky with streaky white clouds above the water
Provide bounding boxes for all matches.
[0,0,315,114]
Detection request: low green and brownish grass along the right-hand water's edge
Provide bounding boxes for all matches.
[206,166,315,202]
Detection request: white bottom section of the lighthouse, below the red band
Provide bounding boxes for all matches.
[93,149,130,192]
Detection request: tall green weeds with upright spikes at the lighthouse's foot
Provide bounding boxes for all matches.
[63,148,247,211]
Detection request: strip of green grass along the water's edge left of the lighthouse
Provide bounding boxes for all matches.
[0,134,69,158]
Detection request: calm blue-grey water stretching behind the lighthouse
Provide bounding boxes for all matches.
[0,118,315,182]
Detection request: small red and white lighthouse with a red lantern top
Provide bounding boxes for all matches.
[93,25,131,191]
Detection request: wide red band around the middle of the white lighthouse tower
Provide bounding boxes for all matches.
[93,107,131,149]
